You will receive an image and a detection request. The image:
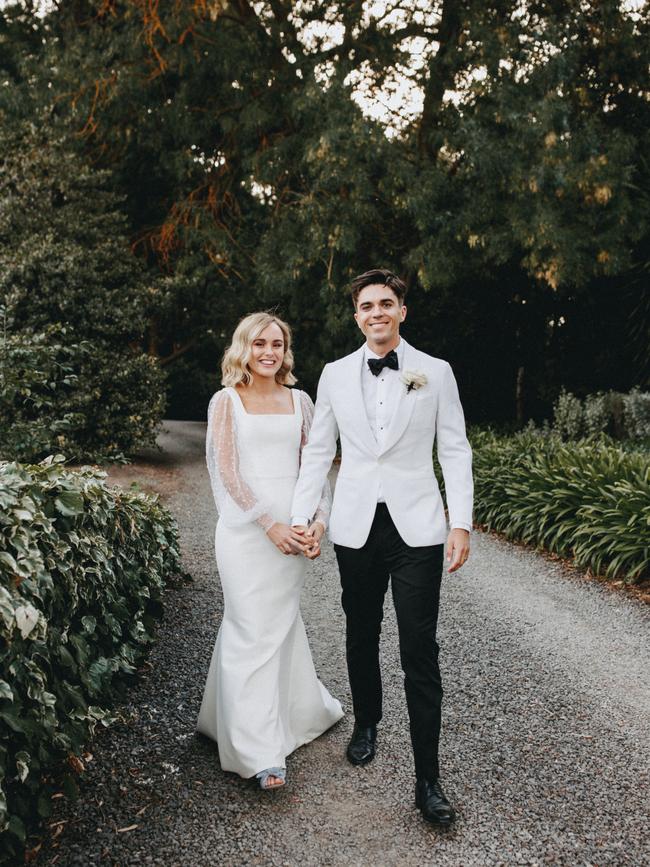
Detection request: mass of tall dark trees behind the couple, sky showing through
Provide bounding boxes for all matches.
[0,0,650,421]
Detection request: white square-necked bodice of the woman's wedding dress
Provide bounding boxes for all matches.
[228,388,302,482]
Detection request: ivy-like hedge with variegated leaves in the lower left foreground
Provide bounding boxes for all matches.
[0,456,180,860]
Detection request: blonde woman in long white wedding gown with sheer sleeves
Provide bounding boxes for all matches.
[197,313,343,789]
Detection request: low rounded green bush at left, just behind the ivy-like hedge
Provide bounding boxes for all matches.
[0,318,165,462]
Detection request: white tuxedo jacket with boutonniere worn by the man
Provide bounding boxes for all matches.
[291,338,473,548]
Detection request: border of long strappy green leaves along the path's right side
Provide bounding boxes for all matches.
[470,430,650,583]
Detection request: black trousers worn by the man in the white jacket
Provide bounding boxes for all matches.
[334,503,444,780]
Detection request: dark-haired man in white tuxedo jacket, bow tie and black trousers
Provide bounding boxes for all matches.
[291,269,472,826]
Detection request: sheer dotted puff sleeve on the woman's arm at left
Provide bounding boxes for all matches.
[205,389,275,531]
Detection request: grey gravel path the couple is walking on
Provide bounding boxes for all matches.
[36,422,650,867]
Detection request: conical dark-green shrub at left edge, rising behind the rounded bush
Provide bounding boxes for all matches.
[0,124,147,346]
